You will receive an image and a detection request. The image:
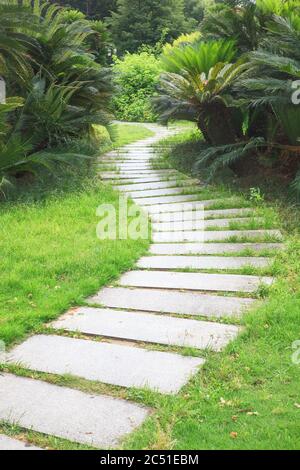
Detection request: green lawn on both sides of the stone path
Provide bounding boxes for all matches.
[0,122,300,450]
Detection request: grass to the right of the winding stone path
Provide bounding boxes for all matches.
[125,126,300,449]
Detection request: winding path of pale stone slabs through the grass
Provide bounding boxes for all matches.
[0,126,282,449]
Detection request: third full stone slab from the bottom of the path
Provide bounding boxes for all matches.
[52,307,239,351]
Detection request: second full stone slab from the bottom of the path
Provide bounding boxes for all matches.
[10,335,203,393]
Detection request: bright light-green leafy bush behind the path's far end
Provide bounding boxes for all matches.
[113,51,161,122]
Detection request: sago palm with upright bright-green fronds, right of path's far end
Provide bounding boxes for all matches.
[155,41,249,145]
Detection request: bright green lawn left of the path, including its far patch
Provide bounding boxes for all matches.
[0,125,152,345]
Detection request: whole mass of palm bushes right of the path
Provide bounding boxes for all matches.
[155,0,300,190]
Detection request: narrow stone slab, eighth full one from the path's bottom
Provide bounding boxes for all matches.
[152,230,282,243]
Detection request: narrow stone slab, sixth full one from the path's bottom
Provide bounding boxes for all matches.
[137,256,272,269]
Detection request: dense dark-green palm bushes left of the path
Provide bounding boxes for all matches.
[0,0,112,193]
